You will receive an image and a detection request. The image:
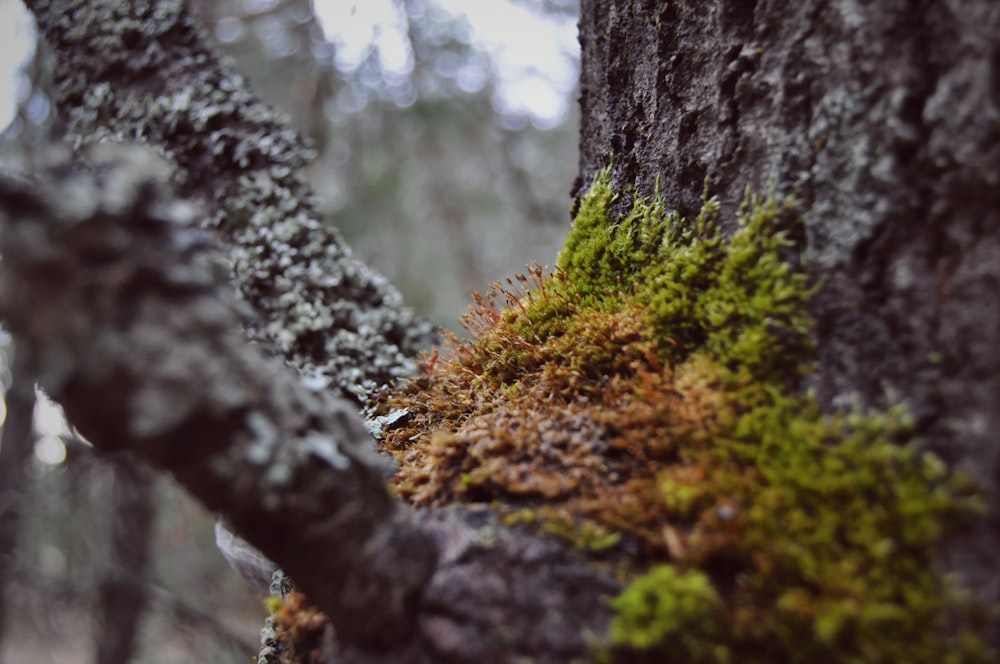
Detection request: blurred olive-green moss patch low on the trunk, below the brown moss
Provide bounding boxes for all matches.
[611,396,991,663]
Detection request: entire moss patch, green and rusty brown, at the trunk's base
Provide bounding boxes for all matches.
[377,173,989,663]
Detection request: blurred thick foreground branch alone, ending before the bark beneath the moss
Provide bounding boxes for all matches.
[0,145,435,644]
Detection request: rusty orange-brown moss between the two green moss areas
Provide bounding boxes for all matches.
[382,278,727,553]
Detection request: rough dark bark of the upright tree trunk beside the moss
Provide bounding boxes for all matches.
[575,0,1000,632]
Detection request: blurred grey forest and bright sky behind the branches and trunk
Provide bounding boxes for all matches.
[0,0,579,664]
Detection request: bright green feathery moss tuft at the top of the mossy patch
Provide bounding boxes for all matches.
[556,176,812,380]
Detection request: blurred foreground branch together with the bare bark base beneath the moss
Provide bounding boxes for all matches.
[0,145,619,664]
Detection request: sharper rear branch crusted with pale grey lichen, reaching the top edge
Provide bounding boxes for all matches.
[25,0,434,394]
